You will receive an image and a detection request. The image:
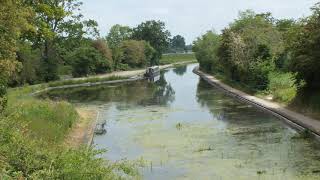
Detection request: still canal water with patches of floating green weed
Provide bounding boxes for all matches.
[40,64,320,180]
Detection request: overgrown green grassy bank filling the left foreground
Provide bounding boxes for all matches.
[0,85,138,179]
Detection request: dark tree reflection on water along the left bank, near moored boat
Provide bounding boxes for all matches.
[40,73,175,106]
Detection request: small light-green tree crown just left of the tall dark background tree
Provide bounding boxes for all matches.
[106,24,132,49]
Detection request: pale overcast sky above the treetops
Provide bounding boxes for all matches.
[82,0,319,43]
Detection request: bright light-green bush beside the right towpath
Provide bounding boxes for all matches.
[268,72,298,103]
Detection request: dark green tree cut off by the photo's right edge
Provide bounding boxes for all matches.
[290,3,320,88]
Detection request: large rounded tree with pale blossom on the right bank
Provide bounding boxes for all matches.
[218,10,284,89]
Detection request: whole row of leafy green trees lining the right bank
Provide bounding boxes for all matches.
[193,4,320,103]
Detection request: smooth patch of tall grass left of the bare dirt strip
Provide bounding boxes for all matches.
[9,99,78,143]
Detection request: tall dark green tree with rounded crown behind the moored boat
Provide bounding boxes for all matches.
[132,20,170,65]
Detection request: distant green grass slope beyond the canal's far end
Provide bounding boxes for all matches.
[160,54,197,65]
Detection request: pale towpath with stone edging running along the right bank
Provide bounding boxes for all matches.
[193,67,320,139]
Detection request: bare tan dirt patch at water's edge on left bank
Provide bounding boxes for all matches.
[65,107,98,147]
